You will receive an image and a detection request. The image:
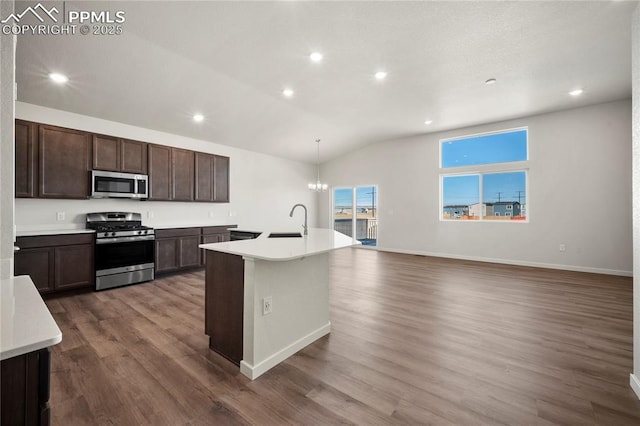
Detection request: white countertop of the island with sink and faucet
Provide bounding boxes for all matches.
[200,228,360,261]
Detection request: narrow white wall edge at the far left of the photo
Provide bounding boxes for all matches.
[0,1,15,279]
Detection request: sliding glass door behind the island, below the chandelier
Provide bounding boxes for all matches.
[333,185,378,246]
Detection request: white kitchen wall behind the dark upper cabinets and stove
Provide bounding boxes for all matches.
[15,102,317,232]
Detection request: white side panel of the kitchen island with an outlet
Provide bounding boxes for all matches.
[240,253,331,379]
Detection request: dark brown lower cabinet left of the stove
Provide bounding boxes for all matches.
[14,233,95,293]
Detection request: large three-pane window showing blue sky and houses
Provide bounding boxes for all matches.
[440,128,529,221]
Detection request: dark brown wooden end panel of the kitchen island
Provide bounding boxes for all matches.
[205,250,244,365]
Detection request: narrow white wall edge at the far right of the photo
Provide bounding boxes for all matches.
[631,6,640,398]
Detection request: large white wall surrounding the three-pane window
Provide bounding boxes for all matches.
[319,100,632,275]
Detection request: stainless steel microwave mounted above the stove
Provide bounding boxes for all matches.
[91,170,149,199]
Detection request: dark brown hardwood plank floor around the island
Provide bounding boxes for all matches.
[47,249,640,426]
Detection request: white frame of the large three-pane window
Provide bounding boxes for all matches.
[438,126,531,223]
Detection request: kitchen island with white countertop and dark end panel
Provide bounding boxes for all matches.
[200,228,360,380]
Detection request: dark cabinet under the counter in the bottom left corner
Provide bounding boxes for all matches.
[0,348,51,426]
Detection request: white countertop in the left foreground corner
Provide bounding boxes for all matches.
[0,275,62,360]
